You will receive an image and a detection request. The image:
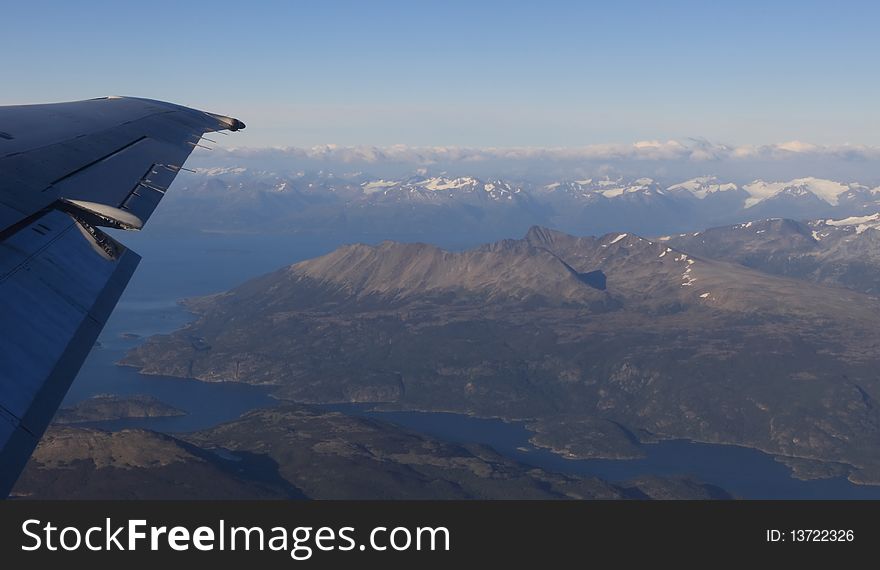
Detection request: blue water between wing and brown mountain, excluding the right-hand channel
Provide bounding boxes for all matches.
[64,233,338,432]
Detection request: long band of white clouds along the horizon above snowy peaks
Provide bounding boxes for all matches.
[190,138,880,185]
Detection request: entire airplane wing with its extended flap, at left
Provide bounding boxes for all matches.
[0,97,244,492]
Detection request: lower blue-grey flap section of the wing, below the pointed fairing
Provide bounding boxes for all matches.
[0,211,139,496]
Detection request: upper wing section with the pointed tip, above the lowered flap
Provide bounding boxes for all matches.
[0,97,244,235]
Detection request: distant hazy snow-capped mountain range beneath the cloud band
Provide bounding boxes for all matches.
[155,167,880,242]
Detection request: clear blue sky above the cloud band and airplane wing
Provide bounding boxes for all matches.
[0,0,880,147]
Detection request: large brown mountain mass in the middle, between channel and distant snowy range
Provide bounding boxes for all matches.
[122,213,880,484]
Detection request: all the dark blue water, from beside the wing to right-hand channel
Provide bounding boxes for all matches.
[65,234,880,499]
